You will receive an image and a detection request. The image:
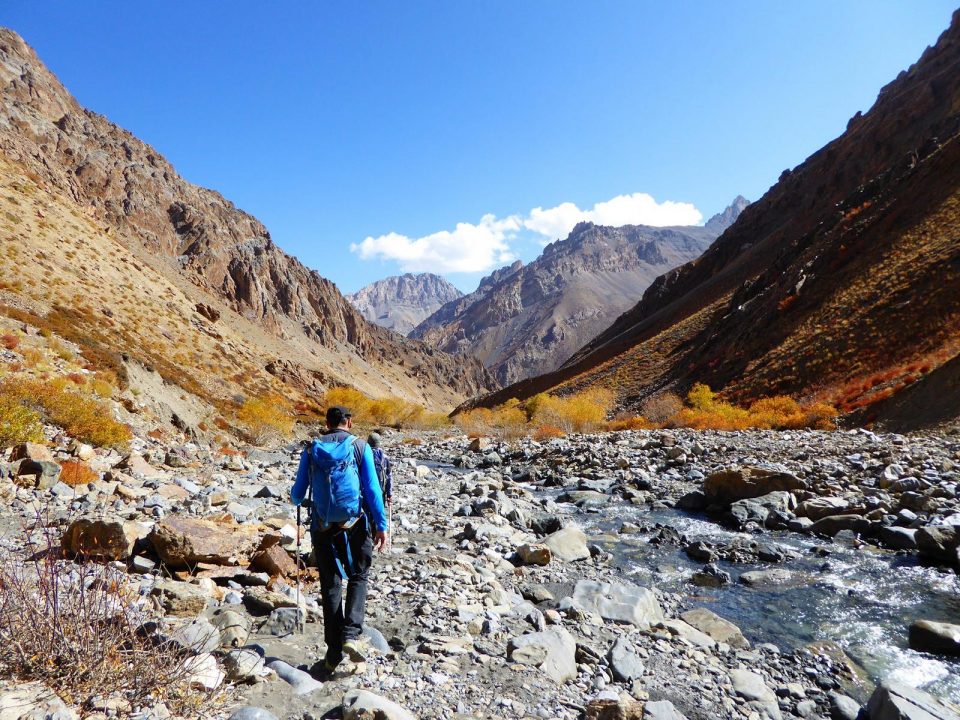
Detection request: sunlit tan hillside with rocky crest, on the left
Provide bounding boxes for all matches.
[0,30,493,416]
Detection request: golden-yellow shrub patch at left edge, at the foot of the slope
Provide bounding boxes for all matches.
[0,377,132,447]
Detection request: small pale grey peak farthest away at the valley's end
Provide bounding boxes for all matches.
[347,273,463,335]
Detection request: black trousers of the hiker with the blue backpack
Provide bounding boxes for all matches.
[312,517,373,661]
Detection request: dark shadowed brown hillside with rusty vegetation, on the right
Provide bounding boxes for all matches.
[468,12,960,428]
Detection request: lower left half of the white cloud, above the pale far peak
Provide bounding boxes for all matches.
[350,215,520,273]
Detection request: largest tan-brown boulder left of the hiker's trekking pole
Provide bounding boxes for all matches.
[148,515,259,568]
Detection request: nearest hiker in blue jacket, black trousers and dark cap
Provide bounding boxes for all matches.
[290,405,388,677]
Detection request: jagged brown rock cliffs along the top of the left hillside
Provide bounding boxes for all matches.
[0,30,492,408]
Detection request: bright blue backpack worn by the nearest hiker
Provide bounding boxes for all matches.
[310,435,361,526]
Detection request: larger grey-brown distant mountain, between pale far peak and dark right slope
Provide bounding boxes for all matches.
[410,196,749,384]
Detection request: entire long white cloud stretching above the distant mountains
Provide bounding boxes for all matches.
[350,193,703,273]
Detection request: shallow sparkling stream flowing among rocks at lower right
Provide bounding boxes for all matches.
[578,505,960,701]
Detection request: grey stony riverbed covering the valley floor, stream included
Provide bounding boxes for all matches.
[0,431,960,720]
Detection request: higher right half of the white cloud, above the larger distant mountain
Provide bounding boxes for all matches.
[523,193,703,242]
